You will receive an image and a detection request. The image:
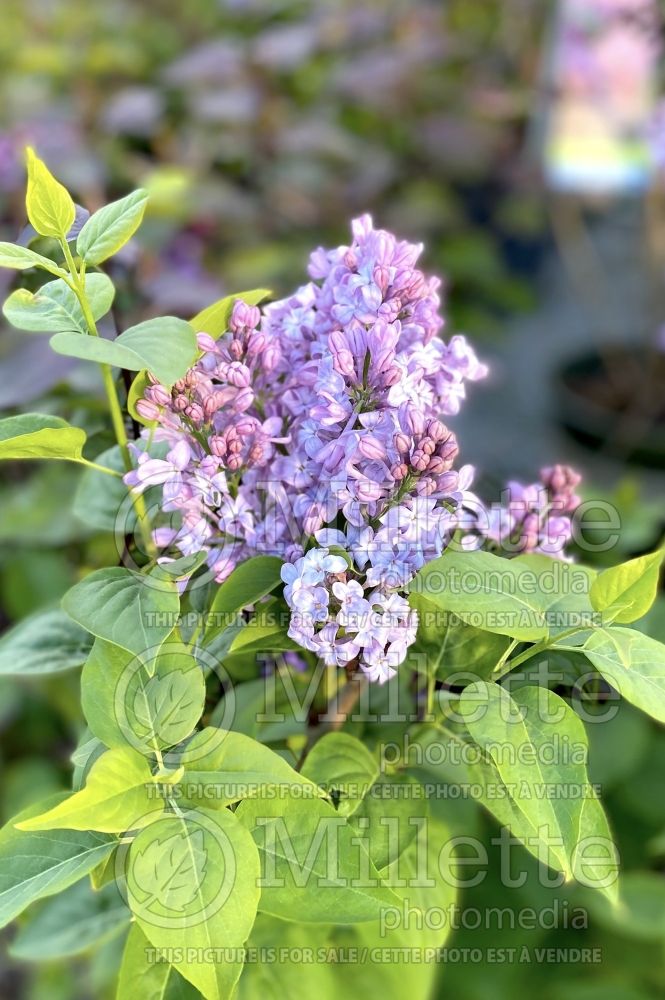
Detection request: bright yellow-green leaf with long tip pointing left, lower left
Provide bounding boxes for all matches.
[16,747,164,833]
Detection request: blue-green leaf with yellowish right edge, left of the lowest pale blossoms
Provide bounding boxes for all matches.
[62,566,180,669]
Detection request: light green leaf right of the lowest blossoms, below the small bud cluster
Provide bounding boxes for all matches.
[410,551,549,642]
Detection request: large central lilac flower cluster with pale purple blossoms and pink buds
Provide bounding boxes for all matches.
[125,216,567,681]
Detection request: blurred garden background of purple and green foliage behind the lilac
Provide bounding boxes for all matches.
[0,0,665,1000]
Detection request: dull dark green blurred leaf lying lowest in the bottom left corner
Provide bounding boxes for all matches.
[10,880,130,962]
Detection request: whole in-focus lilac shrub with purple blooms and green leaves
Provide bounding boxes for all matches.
[0,151,665,1000]
